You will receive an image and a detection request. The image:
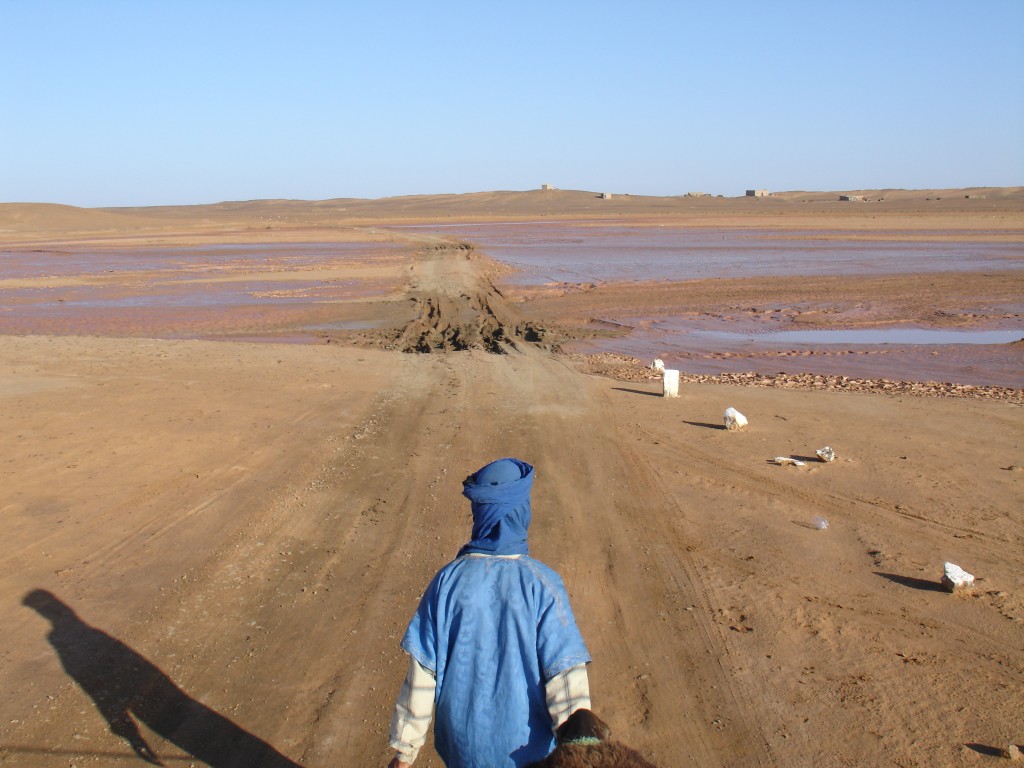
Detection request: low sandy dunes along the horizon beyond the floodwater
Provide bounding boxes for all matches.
[0,186,1024,244]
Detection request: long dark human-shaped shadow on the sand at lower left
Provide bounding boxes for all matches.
[22,590,301,768]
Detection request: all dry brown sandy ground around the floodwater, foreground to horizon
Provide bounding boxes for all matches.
[0,189,1024,768]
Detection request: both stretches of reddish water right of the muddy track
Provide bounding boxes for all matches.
[413,222,1024,387]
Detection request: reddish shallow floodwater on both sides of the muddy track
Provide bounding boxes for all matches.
[0,227,1024,387]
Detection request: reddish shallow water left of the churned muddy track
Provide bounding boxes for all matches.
[0,243,407,339]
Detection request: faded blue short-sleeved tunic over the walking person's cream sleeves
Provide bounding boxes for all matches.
[401,555,590,768]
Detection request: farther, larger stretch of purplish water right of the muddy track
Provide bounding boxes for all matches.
[391,222,1024,285]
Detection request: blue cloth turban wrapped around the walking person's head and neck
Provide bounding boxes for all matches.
[459,459,534,555]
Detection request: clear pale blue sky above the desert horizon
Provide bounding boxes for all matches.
[0,0,1024,206]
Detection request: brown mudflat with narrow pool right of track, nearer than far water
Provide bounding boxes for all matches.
[516,270,1024,389]
